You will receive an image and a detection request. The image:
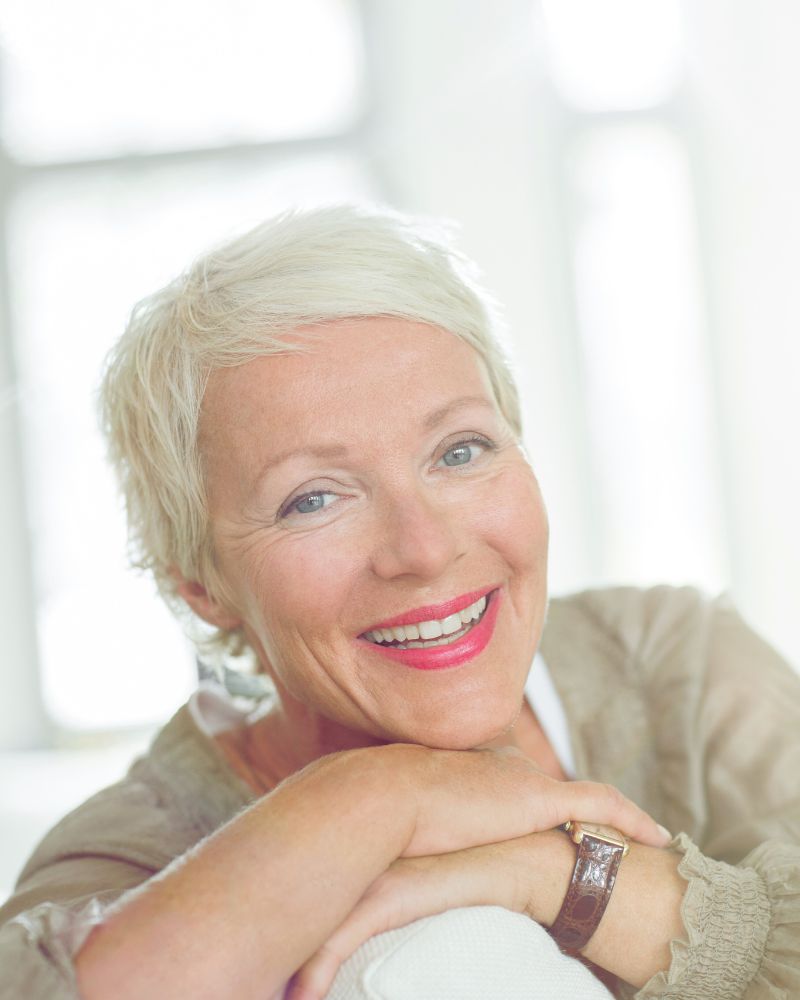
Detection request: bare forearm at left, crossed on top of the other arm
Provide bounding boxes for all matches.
[76,748,414,1000]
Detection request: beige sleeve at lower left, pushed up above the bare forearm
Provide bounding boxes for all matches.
[0,781,191,1000]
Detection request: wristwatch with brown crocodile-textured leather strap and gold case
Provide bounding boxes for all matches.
[550,820,630,955]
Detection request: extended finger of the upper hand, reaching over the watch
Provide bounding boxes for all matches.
[553,781,672,847]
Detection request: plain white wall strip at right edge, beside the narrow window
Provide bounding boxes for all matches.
[686,0,800,666]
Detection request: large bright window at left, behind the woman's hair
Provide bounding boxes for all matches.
[0,0,376,733]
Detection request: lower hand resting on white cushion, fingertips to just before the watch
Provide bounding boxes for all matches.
[286,832,536,1000]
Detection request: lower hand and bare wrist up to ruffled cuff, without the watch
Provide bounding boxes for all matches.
[286,830,686,1000]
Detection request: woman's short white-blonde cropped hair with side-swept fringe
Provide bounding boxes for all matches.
[100,205,522,653]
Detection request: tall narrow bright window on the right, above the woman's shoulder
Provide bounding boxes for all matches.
[542,0,729,589]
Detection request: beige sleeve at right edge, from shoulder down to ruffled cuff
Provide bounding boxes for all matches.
[627,597,800,1000]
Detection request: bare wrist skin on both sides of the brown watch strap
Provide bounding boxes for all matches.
[529,830,686,986]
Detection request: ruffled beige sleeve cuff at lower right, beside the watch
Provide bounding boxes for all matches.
[622,833,800,1000]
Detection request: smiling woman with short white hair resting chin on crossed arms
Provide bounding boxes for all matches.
[0,208,800,1000]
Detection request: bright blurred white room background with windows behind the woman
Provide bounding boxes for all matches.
[0,0,800,894]
